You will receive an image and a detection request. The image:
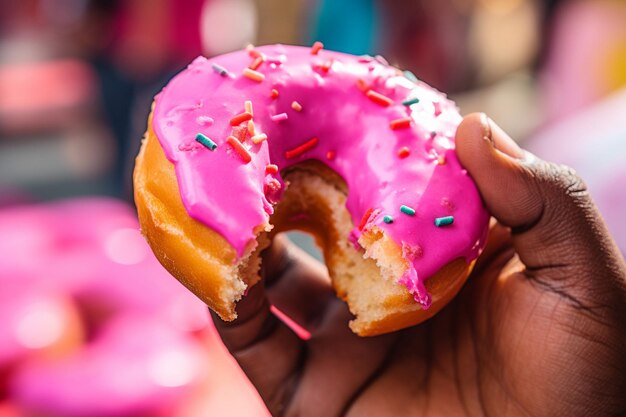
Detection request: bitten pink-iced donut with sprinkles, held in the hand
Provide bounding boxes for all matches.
[134,42,489,336]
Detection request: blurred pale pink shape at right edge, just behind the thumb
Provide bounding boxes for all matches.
[526,89,626,256]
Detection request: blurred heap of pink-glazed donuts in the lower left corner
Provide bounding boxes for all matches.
[0,198,267,417]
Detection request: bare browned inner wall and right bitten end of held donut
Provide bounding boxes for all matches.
[241,160,467,335]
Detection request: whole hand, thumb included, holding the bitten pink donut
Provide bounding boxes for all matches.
[210,115,626,417]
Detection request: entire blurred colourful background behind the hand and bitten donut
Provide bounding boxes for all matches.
[0,0,626,417]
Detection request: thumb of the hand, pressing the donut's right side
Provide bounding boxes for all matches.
[456,114,624,294]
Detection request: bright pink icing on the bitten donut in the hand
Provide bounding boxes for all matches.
[153,45,489,308]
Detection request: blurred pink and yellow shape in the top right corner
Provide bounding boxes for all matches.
[543,0,626,120]
